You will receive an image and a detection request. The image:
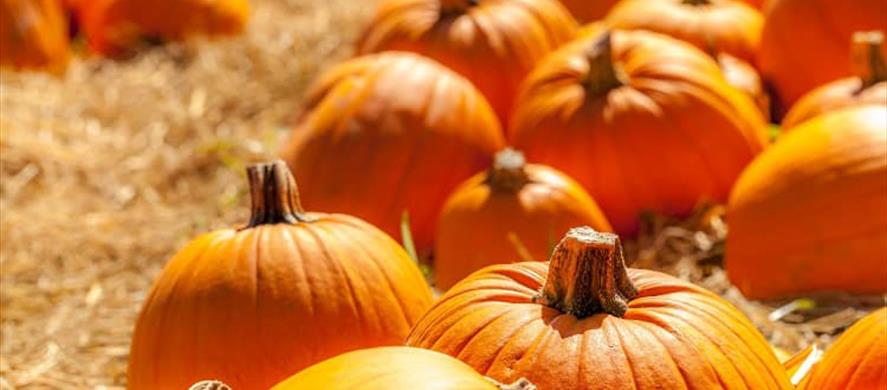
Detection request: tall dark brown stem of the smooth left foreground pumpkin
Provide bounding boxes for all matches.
[246,160,309,228]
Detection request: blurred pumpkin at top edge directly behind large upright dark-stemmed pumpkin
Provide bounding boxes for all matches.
[607,0,764,62]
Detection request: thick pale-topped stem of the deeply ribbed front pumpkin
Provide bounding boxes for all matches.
[536,226,637,318]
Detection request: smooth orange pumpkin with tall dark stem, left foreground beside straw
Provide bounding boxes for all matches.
[128,161,432,389]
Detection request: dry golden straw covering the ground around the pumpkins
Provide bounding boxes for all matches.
[0,0,884,389]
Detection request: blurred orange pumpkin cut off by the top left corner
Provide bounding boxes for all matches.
[0,0,70,73]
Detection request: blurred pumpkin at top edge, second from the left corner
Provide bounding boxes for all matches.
[74,0,249,56]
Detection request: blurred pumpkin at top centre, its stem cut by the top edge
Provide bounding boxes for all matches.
[357,0,577,121]
